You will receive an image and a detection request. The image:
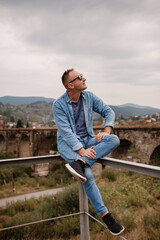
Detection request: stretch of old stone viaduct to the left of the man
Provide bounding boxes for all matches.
[0,127,57,157]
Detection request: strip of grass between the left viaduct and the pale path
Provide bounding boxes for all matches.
[0,162,74,199]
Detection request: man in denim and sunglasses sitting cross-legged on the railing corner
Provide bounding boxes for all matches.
[53,69,124,235]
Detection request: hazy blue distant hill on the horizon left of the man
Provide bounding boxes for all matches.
[0,96,55,106]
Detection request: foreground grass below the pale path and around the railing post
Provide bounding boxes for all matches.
[0,167,160,240]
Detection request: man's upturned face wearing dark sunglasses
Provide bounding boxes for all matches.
[67,70,87,91]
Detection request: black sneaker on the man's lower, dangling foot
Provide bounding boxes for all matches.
[103,213,124,235]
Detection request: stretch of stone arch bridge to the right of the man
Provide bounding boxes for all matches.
[95,126,160,164]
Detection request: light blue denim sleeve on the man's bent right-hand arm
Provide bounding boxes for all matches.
[93,94,115,127]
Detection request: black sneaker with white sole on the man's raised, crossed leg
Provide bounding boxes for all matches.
[65,160,87,183]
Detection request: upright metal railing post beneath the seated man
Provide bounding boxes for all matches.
[78,182,90,240]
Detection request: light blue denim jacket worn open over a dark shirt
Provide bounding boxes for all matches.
[53,91,115,153]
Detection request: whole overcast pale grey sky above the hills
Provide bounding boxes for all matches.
[0,0,160,108]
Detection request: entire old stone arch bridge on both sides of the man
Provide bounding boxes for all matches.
[0,126,160,164]
